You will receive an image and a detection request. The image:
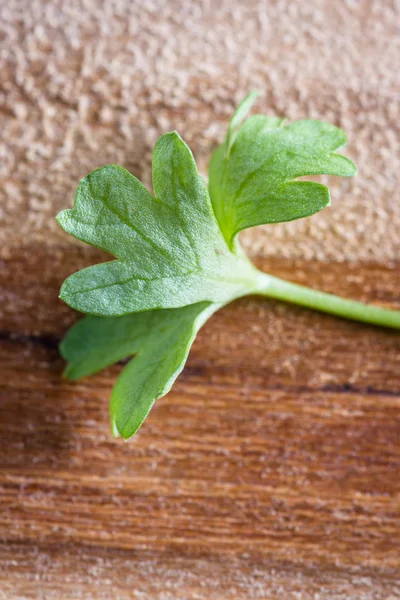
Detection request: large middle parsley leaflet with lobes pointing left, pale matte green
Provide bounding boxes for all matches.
[57,133,254,316]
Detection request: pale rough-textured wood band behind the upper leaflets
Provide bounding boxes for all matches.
[0,0,400,261]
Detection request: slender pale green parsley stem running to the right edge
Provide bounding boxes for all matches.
[255,272,400,329]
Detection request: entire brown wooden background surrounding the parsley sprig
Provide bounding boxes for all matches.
[0,0,400,600]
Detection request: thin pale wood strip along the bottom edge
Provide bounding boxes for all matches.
[0,544,399,600]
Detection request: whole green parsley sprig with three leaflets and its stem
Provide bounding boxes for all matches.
[57,92,400,438]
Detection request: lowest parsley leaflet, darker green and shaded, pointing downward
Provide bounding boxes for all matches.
[60,302,219,439]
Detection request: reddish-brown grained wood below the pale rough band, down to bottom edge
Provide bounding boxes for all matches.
[0,244,400,600]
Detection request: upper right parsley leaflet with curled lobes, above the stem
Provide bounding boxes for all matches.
[209,106,356,249]
